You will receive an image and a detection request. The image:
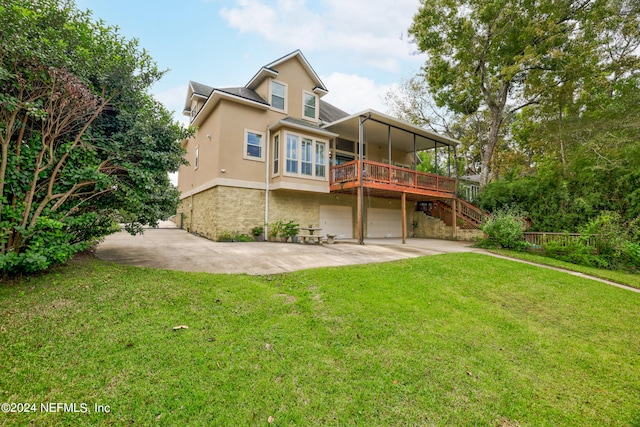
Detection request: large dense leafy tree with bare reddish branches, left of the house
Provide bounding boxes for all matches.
[0,0,189,274]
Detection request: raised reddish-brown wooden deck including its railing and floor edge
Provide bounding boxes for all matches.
[329,160,456,199]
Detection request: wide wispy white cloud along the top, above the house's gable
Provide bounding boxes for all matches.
[220,0,423,72]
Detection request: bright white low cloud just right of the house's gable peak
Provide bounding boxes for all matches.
[320,73,397,114]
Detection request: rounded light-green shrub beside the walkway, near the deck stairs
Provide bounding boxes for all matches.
[480,207,528,251]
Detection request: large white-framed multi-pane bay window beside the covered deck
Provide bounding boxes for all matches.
[282,133,328,180]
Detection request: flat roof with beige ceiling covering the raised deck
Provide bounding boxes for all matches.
[323,109,459,153]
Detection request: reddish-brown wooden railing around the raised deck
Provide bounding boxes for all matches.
[330,160,456,194]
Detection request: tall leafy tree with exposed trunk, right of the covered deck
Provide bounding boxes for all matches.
[410,0,612,186]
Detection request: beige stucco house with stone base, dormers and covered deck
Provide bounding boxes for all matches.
[176,50,480,241]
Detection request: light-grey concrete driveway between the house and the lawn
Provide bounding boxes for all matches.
[96,228,479,274]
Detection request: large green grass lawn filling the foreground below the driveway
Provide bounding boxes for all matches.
[0,253,640,427]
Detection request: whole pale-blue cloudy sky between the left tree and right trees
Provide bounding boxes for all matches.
[76,0,425,122]
